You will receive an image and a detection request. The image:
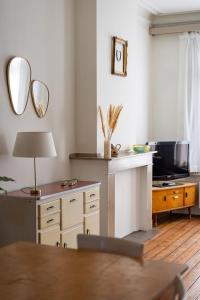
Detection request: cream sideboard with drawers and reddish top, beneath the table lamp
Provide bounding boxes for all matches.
[0,181,100,248]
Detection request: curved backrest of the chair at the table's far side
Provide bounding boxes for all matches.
[77,234,144,259]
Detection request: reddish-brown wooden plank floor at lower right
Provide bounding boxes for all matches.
[145,216,200,300]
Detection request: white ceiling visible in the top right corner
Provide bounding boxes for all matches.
[140,0,200,15]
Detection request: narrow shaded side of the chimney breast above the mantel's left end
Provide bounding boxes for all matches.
[75,0,97,153]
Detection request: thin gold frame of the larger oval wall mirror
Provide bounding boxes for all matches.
[6,56,32,116]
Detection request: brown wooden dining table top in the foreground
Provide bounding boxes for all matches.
[0,242,187,300]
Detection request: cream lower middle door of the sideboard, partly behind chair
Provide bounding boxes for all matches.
[61,225,83,249]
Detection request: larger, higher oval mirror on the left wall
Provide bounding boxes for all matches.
[7,57,31,115]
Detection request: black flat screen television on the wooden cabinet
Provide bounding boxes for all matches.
[147,141,189,180]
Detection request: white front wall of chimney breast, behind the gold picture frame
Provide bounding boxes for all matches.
[97,0,151,152]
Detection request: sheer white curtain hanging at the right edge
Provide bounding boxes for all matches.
[178,32,200,172]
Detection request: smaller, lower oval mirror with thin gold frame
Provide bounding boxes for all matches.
[31,80,49,118]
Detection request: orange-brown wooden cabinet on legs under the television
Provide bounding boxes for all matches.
[152,182,196,226]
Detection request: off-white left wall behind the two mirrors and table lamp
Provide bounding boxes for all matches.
[0,0,75,189]
